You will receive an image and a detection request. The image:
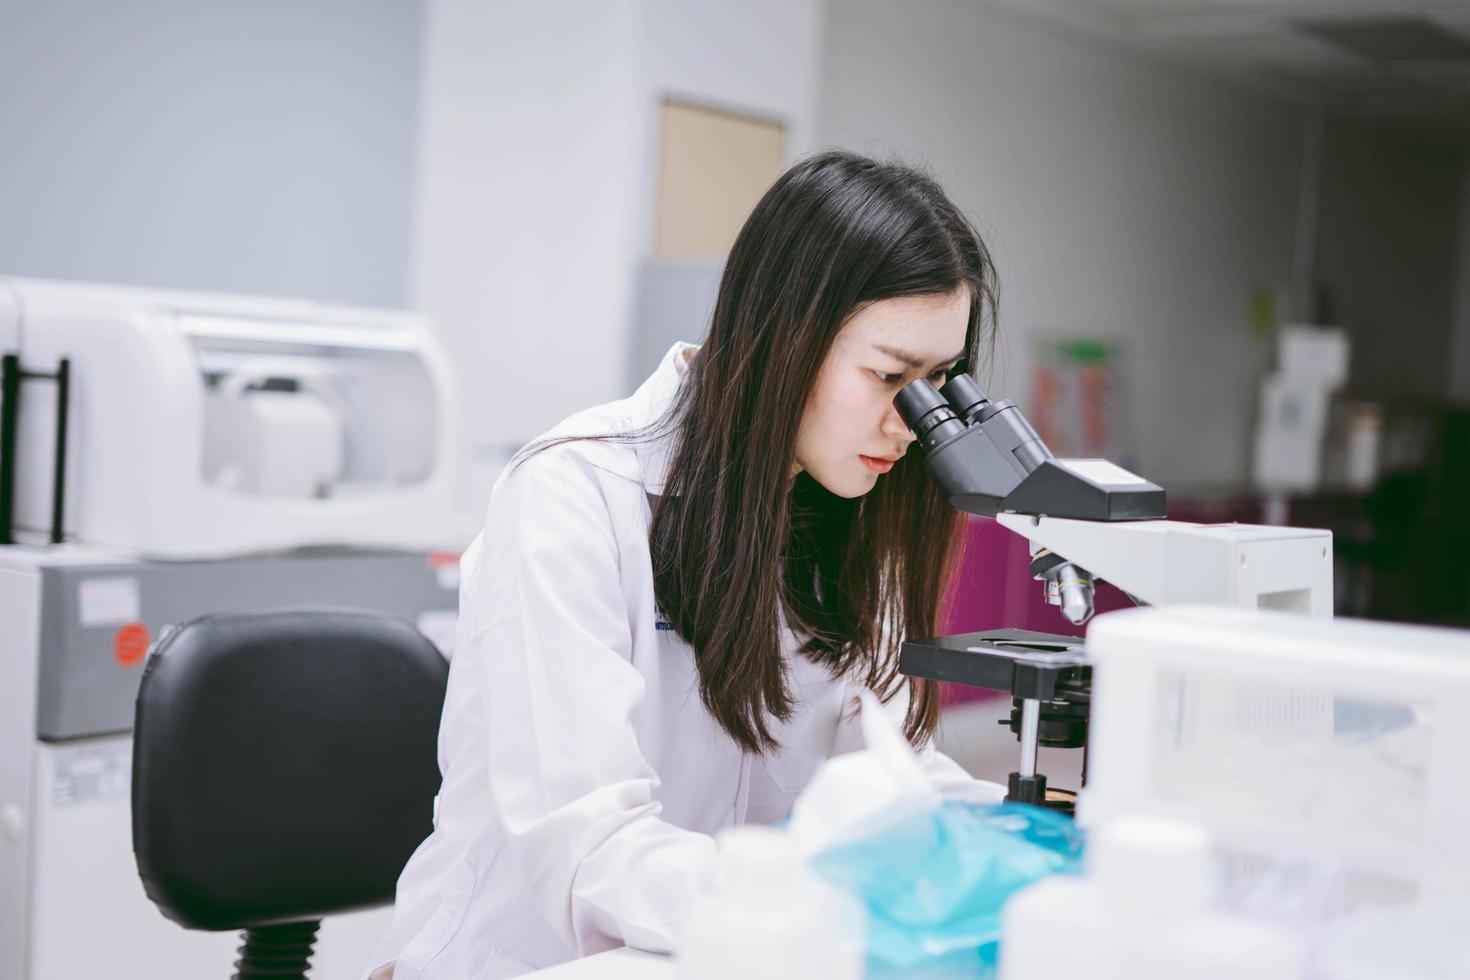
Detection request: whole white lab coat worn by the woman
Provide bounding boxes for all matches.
[370,344,1001,980]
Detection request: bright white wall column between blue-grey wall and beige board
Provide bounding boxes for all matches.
[412,0,639,505]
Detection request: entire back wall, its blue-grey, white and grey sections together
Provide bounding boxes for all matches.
[0,0,1334,513]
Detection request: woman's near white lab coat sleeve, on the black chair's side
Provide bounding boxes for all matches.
[459,450,714,955]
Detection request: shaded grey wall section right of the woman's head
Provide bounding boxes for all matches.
[822,0,1305,486]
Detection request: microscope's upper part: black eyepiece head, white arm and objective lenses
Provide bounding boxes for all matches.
[895,367,1332,626]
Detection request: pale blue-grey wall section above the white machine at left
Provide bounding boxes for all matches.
[0,0,419,306]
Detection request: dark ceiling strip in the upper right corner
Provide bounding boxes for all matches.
[1001,0,1470,137]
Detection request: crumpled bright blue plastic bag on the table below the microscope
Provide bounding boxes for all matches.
[811,802,1083,980]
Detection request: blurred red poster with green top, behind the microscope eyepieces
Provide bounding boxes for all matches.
[1029,336,1133,466]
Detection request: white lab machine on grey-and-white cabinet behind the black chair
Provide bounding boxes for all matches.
[0,278,459,980]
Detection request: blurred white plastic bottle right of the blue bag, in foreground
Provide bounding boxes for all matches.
[1000,817,1301,980]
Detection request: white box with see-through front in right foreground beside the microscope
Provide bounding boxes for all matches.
[1078,605,1470,979]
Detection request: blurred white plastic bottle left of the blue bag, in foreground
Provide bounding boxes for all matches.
[675,826,863,980]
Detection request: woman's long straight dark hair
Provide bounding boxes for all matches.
[650,151,997,752]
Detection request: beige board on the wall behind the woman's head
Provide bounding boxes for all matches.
[654,101,786,260]
